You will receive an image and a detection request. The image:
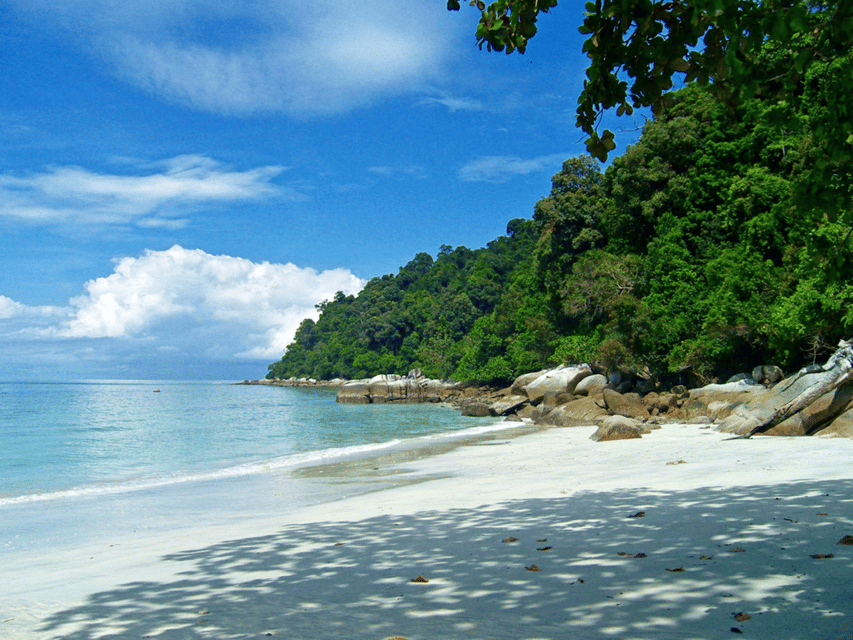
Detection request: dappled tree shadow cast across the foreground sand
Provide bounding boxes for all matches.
[40,478,853,640]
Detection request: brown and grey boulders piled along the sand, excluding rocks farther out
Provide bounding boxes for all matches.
[457,365,853,441]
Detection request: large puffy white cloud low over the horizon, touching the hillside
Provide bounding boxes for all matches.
[54,245,364,360]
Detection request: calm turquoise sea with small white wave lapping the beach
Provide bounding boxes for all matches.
[0,380,509,556]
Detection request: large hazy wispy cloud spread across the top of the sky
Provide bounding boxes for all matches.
[11,0,464,116]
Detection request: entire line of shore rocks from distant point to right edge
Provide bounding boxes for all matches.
[256,350,853,441]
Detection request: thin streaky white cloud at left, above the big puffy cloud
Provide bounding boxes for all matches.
[0,155,290,228]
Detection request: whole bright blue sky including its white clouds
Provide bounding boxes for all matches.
[0,0,632,380]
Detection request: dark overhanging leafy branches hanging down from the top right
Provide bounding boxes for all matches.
[447,0,853,161]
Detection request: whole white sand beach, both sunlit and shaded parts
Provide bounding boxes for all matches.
[0,425,853,640]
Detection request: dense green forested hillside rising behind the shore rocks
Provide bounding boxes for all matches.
[268,77,853,381]
